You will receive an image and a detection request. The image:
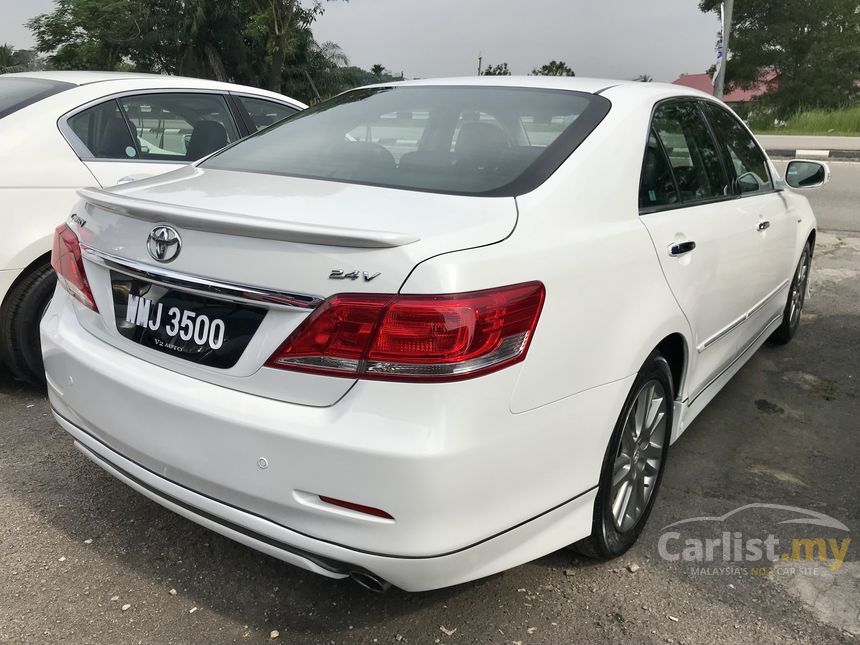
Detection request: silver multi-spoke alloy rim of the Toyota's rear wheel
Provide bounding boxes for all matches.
[610,379,667,532]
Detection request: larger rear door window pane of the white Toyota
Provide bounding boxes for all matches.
[654,101,730,203]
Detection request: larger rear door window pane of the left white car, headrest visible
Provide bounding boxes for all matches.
[119,93,239,162]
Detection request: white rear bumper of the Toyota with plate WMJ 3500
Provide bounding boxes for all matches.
[42,290,630,591]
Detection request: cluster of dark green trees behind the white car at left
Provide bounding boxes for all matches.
[28,0,351,101]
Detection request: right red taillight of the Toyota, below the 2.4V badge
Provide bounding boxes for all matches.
[266,282,545,381]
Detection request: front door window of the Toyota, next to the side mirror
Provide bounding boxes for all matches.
[707,103,773,194]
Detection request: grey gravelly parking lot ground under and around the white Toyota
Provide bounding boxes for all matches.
[0,233,860,645]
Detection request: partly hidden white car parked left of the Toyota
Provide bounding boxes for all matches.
[0,72,306,383]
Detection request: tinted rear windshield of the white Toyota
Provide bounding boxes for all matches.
[202,86,609,195]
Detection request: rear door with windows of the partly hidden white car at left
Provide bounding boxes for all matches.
[65,91,241,187]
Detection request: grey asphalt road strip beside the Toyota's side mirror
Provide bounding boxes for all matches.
[774,161,860,233]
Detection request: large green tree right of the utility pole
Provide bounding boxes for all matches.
[699,0,860,118]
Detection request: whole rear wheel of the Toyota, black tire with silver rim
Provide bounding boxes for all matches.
[573,352,674,560]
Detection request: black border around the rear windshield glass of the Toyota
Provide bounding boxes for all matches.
[204,85,612,197]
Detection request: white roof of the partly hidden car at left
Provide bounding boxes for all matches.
[4,71,307,108]
